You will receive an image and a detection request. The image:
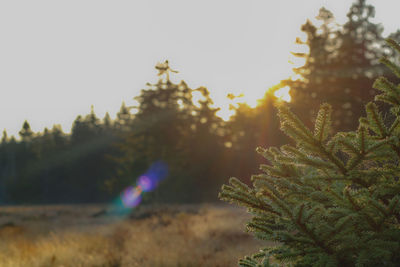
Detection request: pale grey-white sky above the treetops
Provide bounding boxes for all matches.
[0,0,400,138]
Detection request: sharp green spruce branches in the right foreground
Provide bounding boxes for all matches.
[220,40,400,266]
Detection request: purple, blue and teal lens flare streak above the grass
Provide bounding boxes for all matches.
[118,161,168,208]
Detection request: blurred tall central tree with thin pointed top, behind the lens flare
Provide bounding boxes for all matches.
[114,61,224,202]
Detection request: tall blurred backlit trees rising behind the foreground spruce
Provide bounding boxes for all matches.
[282,0,384,130]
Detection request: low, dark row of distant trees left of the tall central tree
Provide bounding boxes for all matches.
[0,110,123,203]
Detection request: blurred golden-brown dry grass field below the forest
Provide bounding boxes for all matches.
[0,205,268,267]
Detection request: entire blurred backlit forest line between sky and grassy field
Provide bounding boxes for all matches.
[0,0,400,204]
